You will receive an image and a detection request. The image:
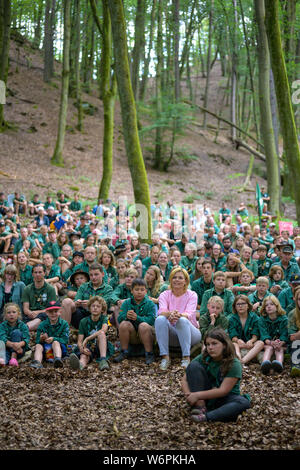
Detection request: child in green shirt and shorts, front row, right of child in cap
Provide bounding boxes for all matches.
[70,295,114,370]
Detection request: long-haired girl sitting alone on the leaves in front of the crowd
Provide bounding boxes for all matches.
[181,328,250,423]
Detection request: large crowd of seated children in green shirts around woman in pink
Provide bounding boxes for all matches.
[0,191,300,421]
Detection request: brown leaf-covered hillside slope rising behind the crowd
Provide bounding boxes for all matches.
[0,36,292,218]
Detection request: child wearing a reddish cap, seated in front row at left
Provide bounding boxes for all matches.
[30,301,69,369]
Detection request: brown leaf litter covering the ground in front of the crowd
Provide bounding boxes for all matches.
[0,326,300,450]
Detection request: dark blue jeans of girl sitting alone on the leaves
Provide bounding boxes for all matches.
[186,361,250,423]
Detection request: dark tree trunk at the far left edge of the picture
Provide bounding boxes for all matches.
[0,0,11,132]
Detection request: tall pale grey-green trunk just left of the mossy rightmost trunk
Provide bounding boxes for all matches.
[254,0,280,216]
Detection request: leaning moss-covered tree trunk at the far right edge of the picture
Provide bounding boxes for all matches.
[265,0,300,224]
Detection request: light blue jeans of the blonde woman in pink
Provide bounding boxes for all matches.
[155,315,201,356]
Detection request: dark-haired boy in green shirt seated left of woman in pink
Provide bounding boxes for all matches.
[114,278,156,364]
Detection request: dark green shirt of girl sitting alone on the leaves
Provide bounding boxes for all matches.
[193,354,245,410]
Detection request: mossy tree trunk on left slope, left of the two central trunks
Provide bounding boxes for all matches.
[51,0,71,166]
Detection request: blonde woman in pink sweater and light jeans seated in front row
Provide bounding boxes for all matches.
[155,267,201,371]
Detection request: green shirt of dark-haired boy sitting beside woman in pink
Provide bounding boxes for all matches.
[118,295,156,328]
